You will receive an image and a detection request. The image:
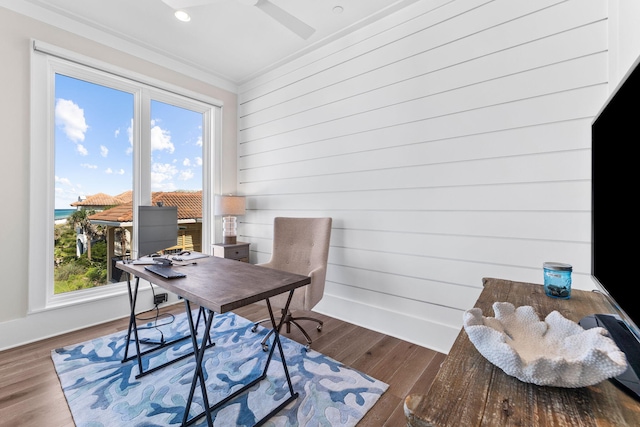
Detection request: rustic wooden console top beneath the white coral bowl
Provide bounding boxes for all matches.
[405,278,640,427]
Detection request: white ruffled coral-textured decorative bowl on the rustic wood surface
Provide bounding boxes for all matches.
[463,302,627,388]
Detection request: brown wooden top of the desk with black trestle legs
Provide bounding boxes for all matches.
[116,256,311,313]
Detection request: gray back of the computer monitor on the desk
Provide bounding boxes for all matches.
[137,206,178,257]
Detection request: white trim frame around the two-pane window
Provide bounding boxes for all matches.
[28,40,223,314]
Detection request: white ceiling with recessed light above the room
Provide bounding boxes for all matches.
[11,0,418,84]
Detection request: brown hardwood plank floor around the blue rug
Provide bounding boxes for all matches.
[0,303,445,427]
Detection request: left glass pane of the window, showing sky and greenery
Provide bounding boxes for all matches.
[52,73,134,294]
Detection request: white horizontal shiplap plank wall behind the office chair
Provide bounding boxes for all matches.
[238,0,608,352]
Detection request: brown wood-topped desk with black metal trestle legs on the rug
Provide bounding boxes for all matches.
[116,257,311,427]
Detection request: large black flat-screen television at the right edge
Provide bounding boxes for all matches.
[580,51,640,399]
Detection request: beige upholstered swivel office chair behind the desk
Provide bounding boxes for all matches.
[252,217,331,351]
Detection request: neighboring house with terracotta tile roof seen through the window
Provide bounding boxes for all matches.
[85,191,202,282]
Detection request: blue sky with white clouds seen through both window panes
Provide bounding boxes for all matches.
[55,74,202,209]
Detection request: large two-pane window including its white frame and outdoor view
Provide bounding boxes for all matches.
[29,43,220,311]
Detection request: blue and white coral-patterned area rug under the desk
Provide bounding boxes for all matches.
[51,311,388,427]
